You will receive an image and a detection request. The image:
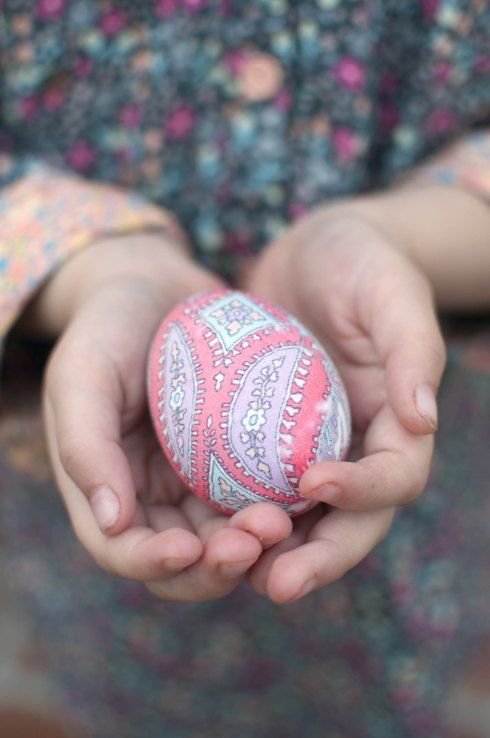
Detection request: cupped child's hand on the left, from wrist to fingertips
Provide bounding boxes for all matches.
[40,234,291,600]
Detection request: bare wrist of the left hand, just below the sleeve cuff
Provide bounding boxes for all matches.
[19,231,215,338]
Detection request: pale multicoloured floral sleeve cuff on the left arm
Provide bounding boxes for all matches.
[0,157,183,340]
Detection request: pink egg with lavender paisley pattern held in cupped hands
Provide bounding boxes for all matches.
[148,291,350,516]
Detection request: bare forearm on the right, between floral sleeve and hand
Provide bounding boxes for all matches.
[350,183,490,311]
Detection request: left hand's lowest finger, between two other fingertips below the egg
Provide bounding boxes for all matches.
[147,528,262,602]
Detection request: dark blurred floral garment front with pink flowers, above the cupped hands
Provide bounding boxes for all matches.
[0,0,490,275]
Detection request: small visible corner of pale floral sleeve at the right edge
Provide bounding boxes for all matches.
[405,130,490,202]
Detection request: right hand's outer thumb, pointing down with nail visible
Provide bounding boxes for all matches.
[363,264,446,434]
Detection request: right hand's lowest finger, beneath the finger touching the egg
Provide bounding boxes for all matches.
[267,509,394,604]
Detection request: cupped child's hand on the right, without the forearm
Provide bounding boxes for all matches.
[246,204,445,603]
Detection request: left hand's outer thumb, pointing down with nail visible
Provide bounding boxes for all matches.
[44,350,136,535]
